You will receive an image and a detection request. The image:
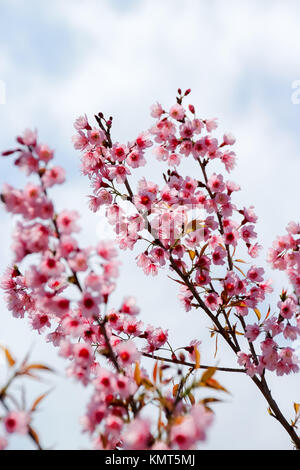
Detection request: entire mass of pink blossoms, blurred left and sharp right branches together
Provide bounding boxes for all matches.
[1,90,300,450]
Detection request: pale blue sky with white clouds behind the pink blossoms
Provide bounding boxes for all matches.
[0,0,300,449]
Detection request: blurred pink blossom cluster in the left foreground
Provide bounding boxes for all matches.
[1,126,217,450]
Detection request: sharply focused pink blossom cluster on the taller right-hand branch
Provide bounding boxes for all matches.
[73,90,300,376]
